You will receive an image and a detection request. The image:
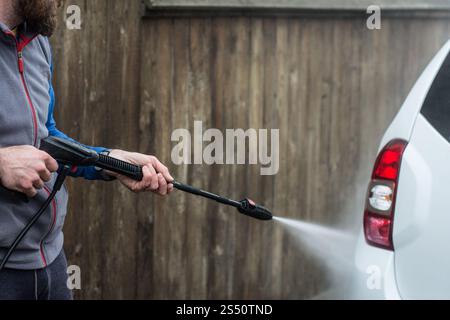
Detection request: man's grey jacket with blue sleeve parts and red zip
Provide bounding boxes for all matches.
[0,23,106,270]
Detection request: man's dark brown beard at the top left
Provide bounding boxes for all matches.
[17,0,59,37]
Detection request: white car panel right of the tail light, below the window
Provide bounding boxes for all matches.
[393,115,450,299]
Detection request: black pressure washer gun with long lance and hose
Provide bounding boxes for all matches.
[0,137,273,271]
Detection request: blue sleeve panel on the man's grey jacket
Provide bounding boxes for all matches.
[46,68,108,180]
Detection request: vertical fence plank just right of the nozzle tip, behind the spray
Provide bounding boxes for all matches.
[279,16,309,297]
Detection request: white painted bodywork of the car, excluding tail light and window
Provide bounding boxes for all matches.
[350,41,450,299]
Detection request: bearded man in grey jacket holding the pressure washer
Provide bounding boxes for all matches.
[0,0,173,299]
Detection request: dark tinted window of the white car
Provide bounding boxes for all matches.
[422,54,450,142]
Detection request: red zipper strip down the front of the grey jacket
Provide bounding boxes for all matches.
[6,32,57,267]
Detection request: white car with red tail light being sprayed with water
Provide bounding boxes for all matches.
[350,41,450,299]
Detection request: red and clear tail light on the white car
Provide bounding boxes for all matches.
[364,140,408,250]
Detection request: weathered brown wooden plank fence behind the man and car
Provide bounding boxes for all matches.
[52,0,450,299]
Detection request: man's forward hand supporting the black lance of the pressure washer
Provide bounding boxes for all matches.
[108,150,174,196]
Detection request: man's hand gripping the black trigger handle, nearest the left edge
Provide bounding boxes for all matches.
[0,146,58,198]
